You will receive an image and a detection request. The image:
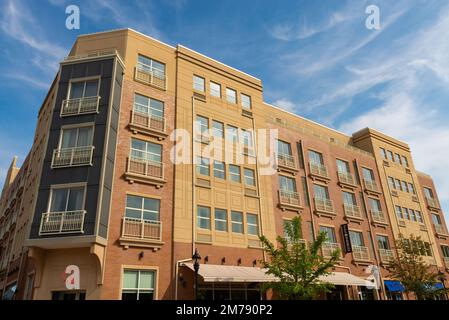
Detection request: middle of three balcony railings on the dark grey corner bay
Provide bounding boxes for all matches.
[51,146,94,168]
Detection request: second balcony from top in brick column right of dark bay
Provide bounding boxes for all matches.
[129,110,167,140]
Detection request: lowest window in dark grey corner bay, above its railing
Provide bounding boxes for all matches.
[49,187,84,212]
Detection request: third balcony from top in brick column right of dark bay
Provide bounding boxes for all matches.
[125,155,165,188]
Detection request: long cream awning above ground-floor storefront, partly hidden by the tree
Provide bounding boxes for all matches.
[183,263,373,287]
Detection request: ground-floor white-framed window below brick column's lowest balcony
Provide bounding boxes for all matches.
[122,270,154,300]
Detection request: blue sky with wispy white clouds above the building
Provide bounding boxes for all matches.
[0,0,449,225]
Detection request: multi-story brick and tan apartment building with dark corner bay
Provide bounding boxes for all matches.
[0,29,449,299]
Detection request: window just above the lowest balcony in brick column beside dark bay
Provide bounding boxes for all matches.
[125,195,160,221]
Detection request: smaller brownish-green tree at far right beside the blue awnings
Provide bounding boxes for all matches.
[387,235,446,300]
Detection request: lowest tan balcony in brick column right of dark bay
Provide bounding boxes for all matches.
[119,217,163,251]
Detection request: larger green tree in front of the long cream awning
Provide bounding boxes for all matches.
[260,217,340,300]
